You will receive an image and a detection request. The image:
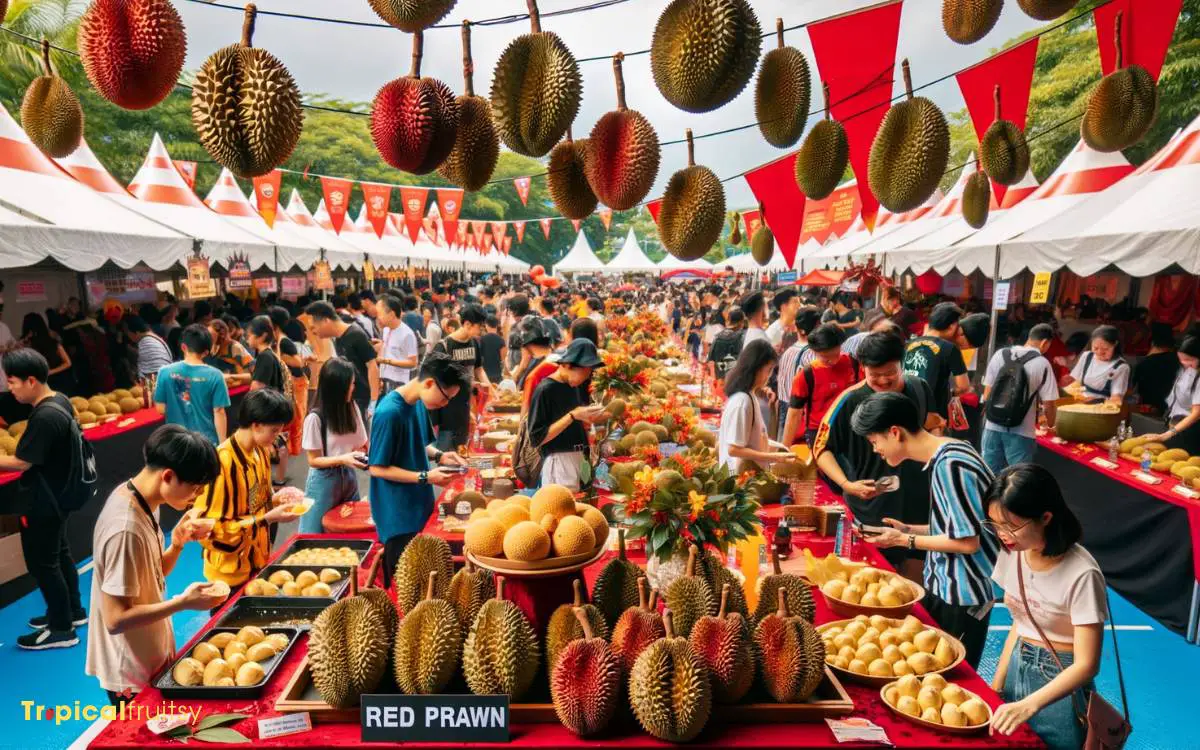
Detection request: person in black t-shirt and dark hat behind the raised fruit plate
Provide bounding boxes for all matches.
[527,338,607,491]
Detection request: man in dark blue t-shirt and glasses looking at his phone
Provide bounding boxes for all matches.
[368,352,469,586]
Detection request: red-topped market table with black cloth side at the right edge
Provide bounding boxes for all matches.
[1034,434,1200,643]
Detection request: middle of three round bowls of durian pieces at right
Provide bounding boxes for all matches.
[817,614,966,686]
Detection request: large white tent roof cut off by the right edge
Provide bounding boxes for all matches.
[1000,118,1200,277]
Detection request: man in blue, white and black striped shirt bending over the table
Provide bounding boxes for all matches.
[851,392,998,667]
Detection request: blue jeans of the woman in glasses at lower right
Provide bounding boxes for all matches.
[1001,641,1096,750]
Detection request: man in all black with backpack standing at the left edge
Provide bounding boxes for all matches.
[0,348,96,650]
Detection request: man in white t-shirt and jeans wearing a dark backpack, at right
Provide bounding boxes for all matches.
[980,323,1058,472]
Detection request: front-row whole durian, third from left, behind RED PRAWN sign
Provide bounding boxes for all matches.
[462,578,540,701]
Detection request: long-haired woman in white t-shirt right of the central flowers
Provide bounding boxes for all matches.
[718,340,794,474]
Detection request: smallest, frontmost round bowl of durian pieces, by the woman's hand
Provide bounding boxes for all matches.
[880,674,991,734]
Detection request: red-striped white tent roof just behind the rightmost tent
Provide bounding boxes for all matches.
[912,140,1133,278]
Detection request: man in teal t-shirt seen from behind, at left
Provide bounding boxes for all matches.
[154,323,229,445]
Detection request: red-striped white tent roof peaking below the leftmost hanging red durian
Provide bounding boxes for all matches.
[127,133,275,268]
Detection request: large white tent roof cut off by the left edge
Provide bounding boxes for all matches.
[0,107,192,271]
